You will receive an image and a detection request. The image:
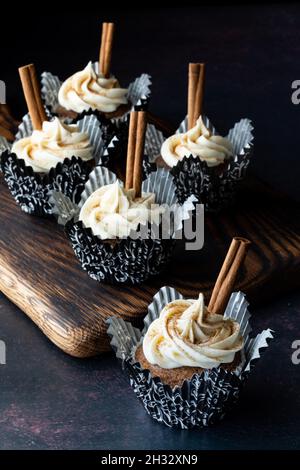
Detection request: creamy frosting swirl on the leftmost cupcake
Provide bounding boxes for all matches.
[12,118,93,173]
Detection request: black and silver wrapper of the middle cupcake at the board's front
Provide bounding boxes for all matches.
[52,167,194,284]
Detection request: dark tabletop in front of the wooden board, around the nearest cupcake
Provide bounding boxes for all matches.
[0,288,300,450]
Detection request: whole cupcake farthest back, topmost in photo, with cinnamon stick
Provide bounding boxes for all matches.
[42,23,151,127]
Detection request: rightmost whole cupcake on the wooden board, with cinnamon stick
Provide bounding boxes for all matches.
[148,64,253,211]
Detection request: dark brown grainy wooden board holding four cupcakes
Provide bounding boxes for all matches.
[0,174,300,357]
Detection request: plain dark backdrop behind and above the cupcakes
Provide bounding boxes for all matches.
[0,2,300,198]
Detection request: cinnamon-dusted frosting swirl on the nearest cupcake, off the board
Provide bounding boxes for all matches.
[143,294,244,369]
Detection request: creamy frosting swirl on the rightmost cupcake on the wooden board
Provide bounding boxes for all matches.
[161,116,233,167]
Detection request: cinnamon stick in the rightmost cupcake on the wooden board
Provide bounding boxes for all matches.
[188,63,205,129]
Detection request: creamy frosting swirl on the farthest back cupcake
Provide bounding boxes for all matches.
[58,62,128,113]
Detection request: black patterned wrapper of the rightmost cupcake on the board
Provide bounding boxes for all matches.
[150,116,253,212]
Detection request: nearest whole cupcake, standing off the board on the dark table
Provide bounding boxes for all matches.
[108,238,273,429]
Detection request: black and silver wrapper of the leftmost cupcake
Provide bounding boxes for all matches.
[0,114,104,216]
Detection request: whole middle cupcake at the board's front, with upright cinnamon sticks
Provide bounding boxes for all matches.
[52,111,194,284]
